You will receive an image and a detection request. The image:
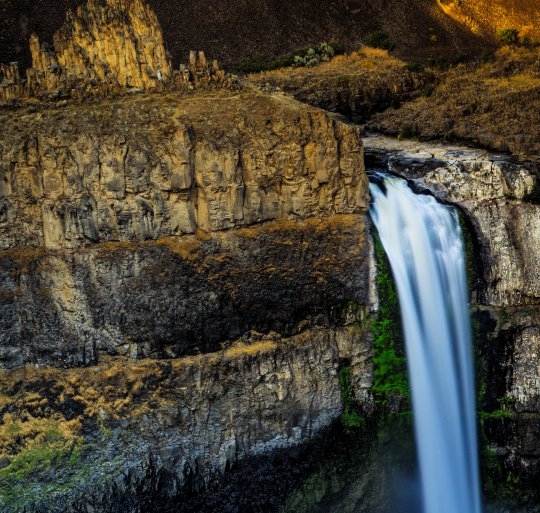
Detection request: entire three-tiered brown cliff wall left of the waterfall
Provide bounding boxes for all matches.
[0,91,374,513]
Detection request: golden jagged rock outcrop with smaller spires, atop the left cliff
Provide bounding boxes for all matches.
[0,0,238,105]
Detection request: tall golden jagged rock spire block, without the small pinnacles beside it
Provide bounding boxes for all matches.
[28,0,172,90]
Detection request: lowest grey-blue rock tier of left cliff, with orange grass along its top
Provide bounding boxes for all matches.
[0,324,371,513]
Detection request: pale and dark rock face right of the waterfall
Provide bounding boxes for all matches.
[365,137,540,485]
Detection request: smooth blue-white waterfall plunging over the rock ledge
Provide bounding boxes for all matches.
[370,176,481,513]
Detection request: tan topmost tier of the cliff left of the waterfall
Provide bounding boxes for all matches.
[0,93,367,249]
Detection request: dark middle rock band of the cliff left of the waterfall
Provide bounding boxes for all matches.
[0,215,370,368]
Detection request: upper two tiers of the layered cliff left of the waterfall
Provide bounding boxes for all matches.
[0,93,367,367]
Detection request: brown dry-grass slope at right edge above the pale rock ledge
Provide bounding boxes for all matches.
[370,47,540,159]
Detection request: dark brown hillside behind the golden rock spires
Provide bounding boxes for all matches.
[0,0,489,71]
